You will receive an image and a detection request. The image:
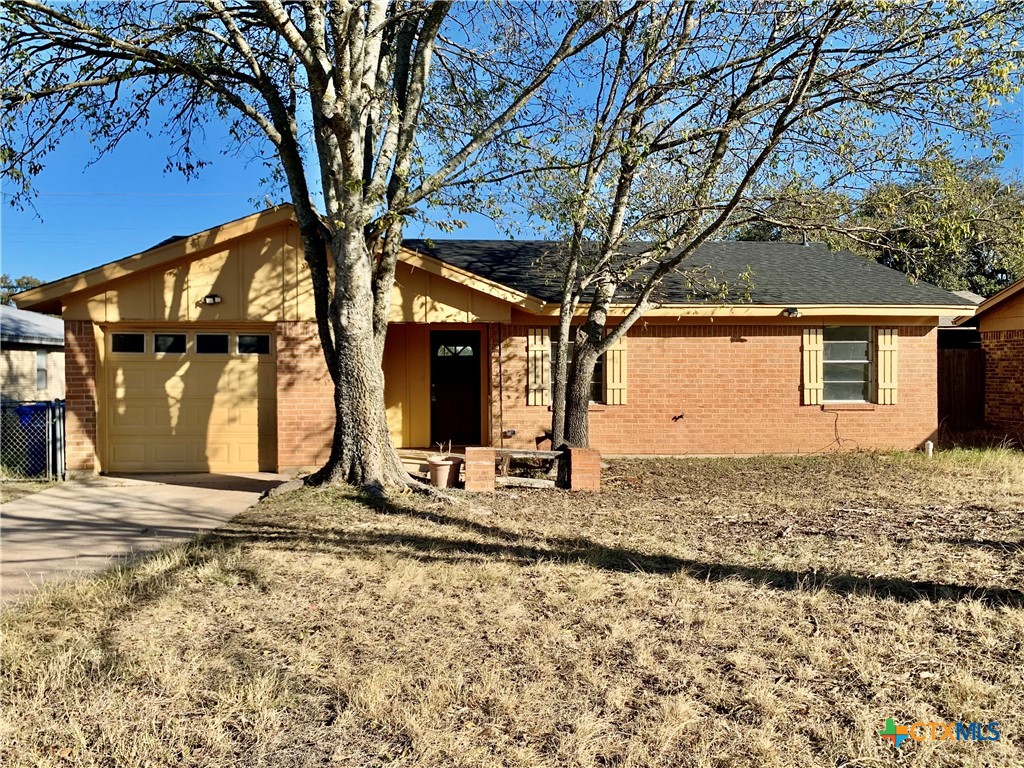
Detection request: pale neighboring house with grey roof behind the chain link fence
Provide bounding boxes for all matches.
[0,304,65,400]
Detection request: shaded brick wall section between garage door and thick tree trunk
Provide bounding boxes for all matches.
[276,322,334,472]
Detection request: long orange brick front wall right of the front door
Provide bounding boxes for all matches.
[492,324,938,455]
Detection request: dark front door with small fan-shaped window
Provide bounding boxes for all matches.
[430,331,480,445]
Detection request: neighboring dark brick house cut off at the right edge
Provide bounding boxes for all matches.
[962,280,1024,435]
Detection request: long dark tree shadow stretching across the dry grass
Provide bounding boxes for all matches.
[208,489,1024,608]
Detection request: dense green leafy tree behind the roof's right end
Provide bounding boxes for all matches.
[736,150,1024,296]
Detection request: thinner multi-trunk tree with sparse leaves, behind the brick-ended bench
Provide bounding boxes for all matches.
[503,0,1024,445]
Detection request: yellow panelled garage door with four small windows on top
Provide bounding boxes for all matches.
[104,329,278,472]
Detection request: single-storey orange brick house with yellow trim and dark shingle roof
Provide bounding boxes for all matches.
[17,207,973,479]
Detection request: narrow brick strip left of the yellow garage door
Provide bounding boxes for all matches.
[65,321,99,474]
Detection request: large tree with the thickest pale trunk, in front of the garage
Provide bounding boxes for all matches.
[0,0,640,487]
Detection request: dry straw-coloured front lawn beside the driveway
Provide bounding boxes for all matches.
[0,451,1024,768]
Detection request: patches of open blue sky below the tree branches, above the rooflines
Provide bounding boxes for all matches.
[0,97,1024,281]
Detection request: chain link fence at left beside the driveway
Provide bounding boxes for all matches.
[0,399,65,480]
